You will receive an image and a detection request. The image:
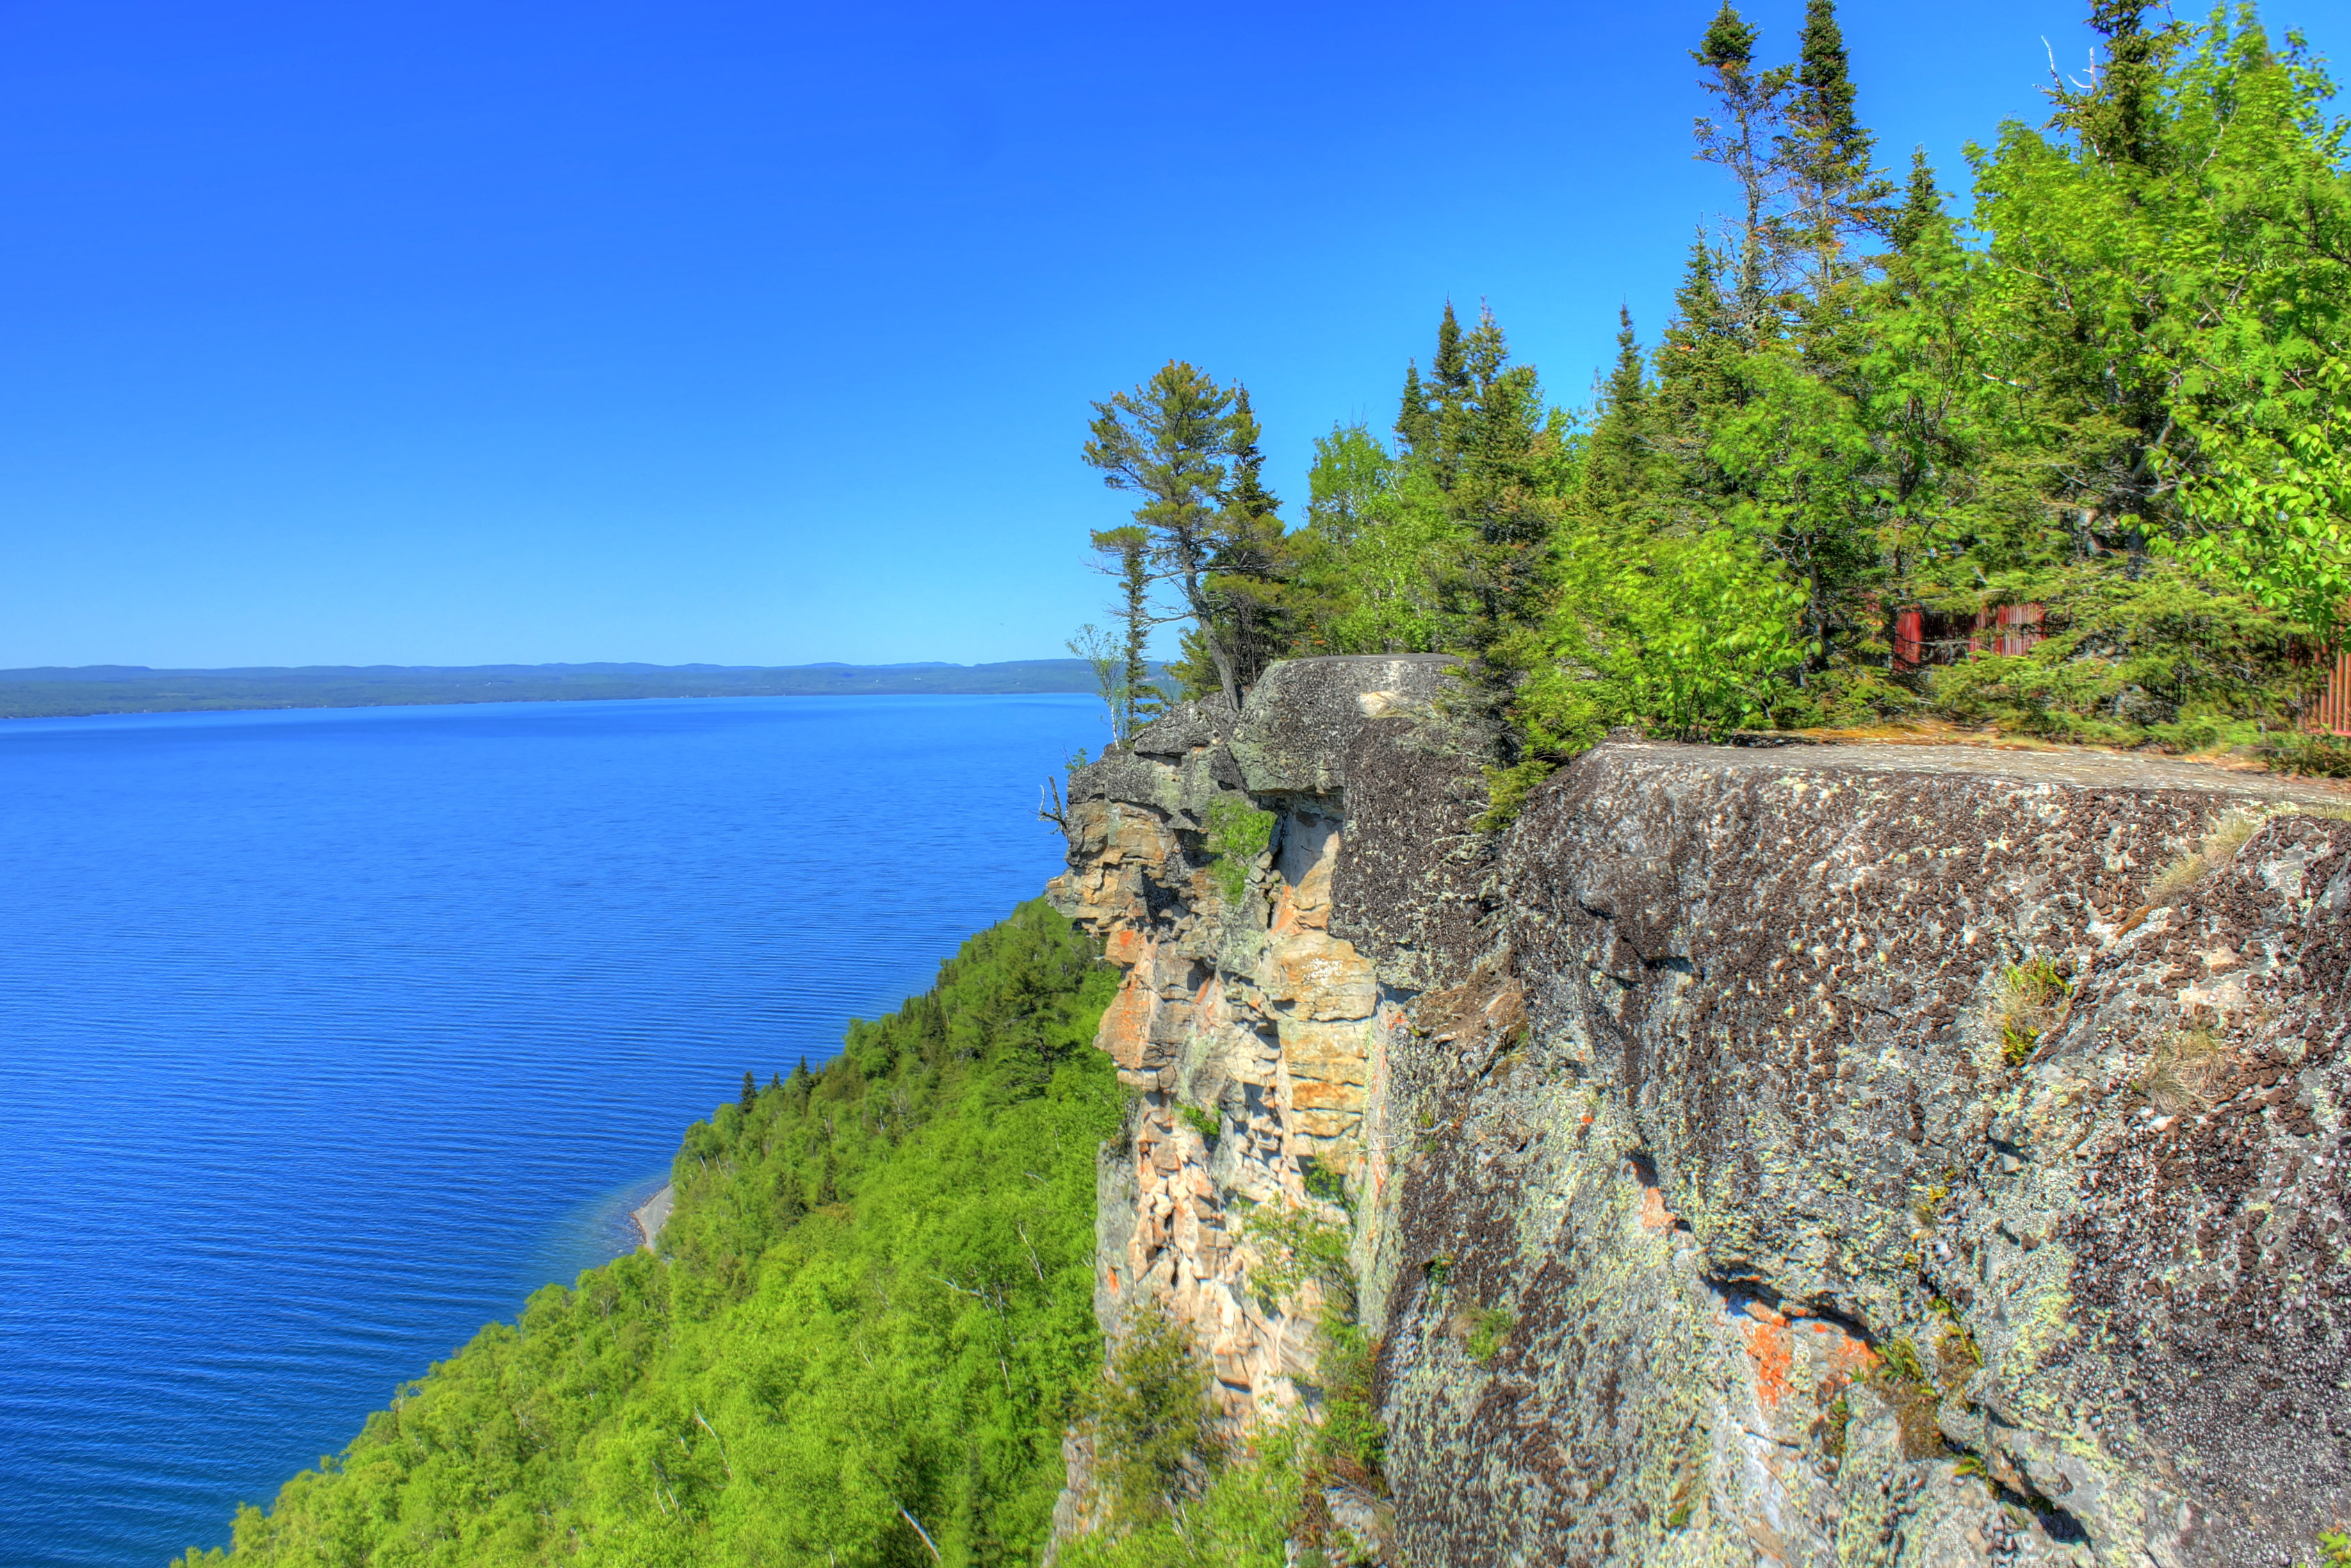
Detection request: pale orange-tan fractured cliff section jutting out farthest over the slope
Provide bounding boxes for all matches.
[1048,658,1410,1457]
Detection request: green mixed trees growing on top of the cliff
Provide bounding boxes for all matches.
[1072,0,2351,816]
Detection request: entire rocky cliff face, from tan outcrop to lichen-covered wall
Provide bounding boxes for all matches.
[1053,658,2351,1568]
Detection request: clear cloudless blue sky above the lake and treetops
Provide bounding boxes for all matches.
[0,0,2351,665]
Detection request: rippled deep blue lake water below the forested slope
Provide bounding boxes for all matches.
[0,696,1100,1568]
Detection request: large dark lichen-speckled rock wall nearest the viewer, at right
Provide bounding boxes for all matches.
[1385,745,2351,1563]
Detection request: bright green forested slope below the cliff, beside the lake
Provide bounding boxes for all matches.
[184,903,1121,1568]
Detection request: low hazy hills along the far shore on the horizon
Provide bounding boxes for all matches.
[0,658,1156,719]
